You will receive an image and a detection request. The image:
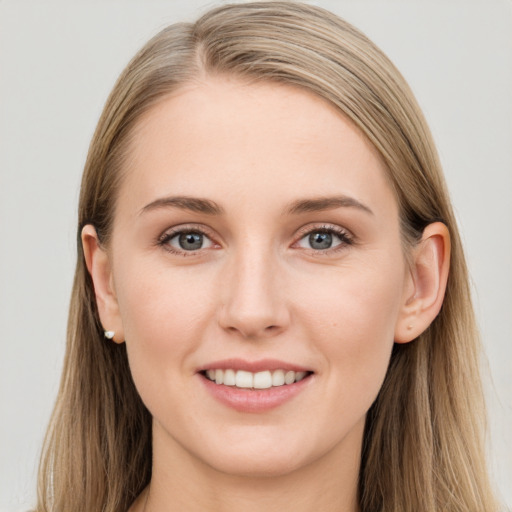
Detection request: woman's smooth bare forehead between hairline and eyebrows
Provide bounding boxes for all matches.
[117,77,394,220]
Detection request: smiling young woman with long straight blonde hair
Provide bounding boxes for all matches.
[38,2,496,512]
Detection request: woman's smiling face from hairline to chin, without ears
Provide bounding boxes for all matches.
[103,78,408,475]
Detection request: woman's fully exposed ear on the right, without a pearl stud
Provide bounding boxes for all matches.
[395,222,450,343]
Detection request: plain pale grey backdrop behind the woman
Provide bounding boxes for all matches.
[0,0,512,512]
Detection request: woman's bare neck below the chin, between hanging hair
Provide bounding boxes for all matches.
[139,418,363,512]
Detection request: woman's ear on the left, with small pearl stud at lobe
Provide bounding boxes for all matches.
[82,224,124,343]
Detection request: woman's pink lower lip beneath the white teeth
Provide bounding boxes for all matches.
[198,374,311,413]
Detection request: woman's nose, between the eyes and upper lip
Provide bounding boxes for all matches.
[219,245,290,340]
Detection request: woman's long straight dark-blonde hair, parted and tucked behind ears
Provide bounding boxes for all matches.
[37,1,496,512]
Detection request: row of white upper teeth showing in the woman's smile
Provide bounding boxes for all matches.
[205,369,308,389]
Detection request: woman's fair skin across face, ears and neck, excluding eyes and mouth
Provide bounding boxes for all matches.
[83,78,449,512]
